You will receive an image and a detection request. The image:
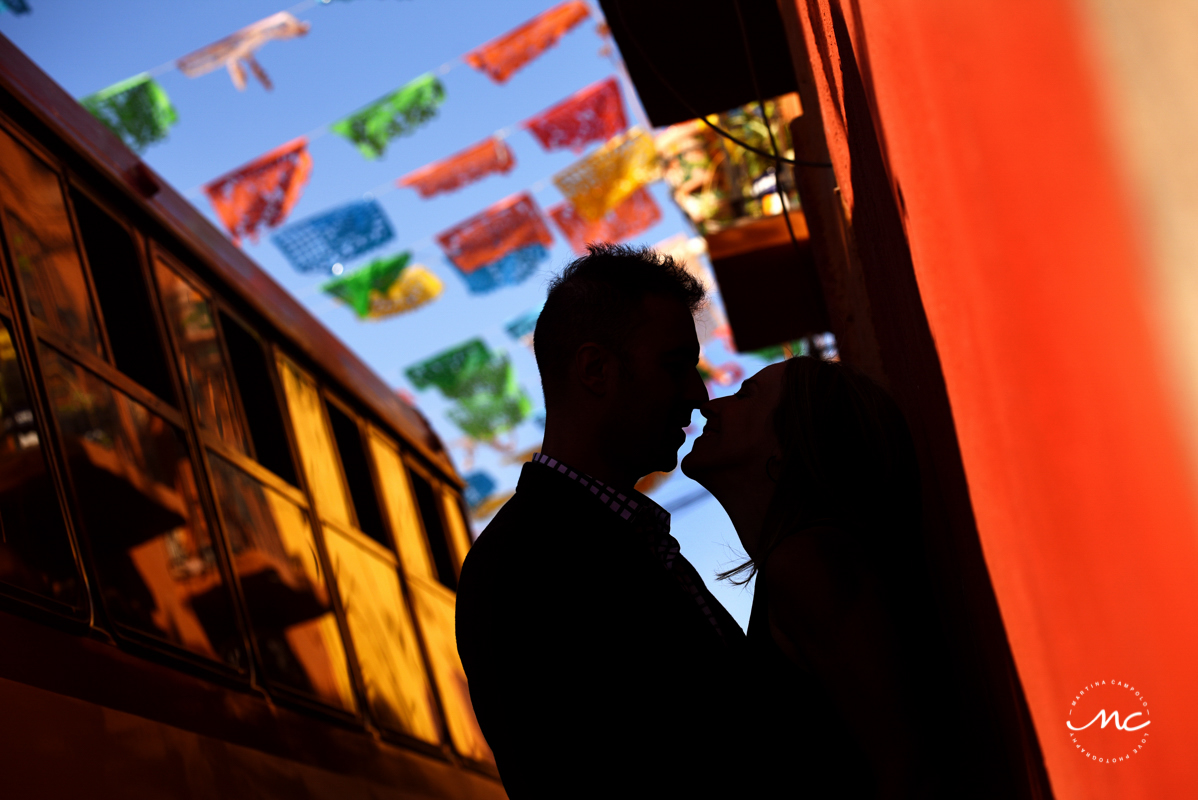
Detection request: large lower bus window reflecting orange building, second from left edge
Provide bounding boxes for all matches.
[41,346,243,666]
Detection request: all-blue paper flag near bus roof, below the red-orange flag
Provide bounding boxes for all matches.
[271,200,395,272]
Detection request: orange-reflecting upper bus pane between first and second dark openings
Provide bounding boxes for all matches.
[156,261,246,453]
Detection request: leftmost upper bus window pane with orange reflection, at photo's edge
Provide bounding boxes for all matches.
[0,131,103,356]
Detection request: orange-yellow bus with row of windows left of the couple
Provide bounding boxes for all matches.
[0,37,504,798]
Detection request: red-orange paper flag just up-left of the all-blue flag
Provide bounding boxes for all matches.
[204,137,311,244]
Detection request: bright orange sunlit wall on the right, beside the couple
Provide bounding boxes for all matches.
[797,0,1198,800]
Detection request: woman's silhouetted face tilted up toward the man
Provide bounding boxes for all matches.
[682,362,786,488]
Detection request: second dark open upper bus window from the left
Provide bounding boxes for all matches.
[219,311,298,486]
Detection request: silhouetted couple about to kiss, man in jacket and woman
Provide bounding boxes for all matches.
[456,244,934,800]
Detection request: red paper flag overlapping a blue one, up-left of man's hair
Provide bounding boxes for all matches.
[437,192,553,273]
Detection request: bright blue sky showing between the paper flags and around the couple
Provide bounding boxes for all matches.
[0,0,764,626]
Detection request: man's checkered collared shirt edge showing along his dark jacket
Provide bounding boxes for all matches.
[532,453,727,641]
